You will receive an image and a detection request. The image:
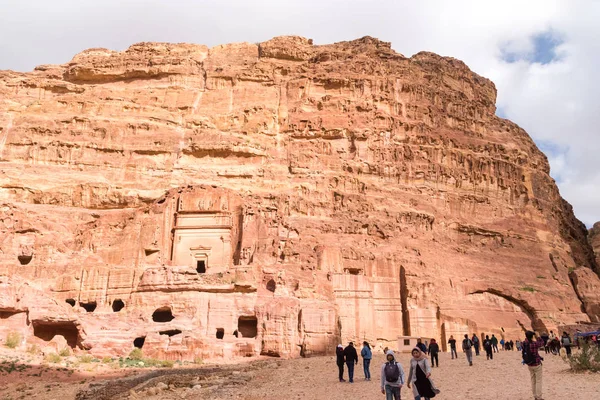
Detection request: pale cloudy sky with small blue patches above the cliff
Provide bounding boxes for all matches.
[0,0,600,226]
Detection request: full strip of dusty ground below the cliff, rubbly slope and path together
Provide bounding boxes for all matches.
[0,350,600,400]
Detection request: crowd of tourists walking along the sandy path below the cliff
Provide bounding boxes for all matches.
[336,331,580,400]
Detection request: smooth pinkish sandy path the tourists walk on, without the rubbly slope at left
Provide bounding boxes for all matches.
[226,351,600,400]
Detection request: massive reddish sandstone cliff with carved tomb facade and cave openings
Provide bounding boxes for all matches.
[0,37,598,360]
